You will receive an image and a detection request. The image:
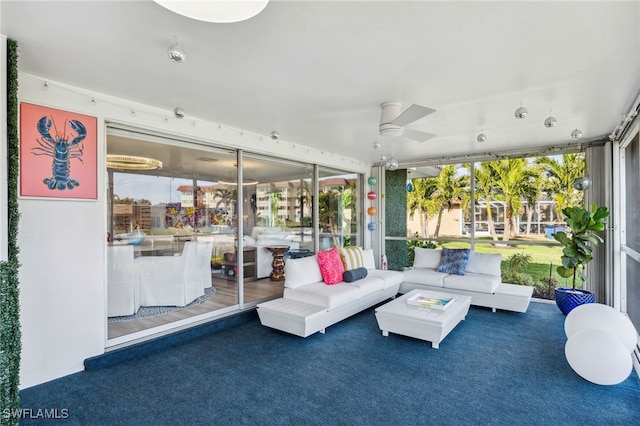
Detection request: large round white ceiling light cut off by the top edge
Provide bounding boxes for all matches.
[154,0,269,23]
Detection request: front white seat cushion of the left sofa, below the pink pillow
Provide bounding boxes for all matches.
[283,280,368,309]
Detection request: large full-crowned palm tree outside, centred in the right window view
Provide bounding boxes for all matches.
[489,158,535,241]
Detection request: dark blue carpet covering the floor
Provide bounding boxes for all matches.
[21,303,640,425]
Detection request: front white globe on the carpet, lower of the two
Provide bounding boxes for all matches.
[564,329,633,385]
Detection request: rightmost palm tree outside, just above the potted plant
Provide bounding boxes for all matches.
[537,153,585,218]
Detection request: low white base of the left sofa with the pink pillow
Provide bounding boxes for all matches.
[258,285,398,337]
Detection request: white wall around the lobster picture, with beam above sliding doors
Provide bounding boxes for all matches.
[18,73,370,388]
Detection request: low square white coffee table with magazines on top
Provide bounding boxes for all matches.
[376,290,471,349]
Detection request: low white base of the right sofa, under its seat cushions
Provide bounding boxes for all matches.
[399,282,533,312]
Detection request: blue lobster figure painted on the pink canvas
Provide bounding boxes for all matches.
[32,116,87,191]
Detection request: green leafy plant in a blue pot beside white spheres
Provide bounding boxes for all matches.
[553,204,610,315]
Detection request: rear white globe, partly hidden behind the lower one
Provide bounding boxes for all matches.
[564,303,638,353]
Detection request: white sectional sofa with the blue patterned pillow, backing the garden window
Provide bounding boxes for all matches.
[399,248,533,312]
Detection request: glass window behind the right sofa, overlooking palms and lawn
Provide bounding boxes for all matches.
[407,153,585,299]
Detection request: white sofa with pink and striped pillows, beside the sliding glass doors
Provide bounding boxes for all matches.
[257,250,403,337]
